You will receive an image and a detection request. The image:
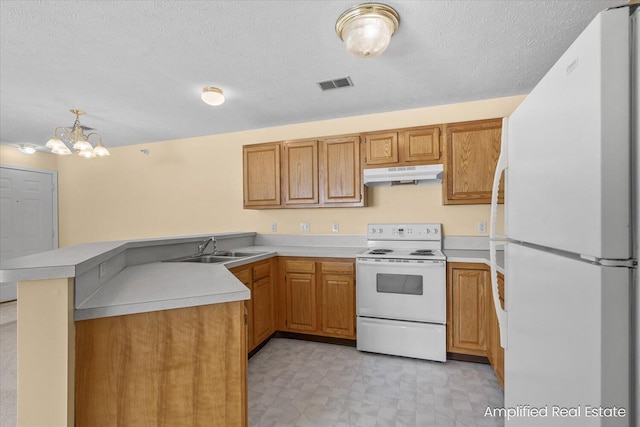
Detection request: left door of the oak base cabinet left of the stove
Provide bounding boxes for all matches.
[285,273,318,331]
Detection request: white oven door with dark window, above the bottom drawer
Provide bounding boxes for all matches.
[356,258,447,324]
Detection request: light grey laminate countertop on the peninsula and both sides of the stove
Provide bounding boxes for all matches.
[0,232,504,320]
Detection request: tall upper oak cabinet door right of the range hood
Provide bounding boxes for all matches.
[443,119,504,204]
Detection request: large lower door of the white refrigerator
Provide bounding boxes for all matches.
[504,243,631,427]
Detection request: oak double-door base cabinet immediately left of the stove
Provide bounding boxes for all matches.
[278,257,356,339]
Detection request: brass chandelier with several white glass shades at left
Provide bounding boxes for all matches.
[45,109,111,158]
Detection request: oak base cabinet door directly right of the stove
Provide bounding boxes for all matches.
[447,263,489,356]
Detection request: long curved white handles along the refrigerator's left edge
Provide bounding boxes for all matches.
[489,117,509,348]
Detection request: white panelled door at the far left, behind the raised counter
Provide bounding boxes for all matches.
[0,166,58,302]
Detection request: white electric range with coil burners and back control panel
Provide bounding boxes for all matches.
[356,223,447,362]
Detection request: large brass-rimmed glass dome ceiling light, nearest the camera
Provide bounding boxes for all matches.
[336,3,400,58]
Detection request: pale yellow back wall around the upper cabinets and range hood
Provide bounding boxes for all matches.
[58,96,524,247]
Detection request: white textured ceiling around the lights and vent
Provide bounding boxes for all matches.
[0,0,626,151]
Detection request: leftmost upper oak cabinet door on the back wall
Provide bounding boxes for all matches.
[242,143,281,208]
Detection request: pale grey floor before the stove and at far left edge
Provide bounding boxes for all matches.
[0,302,504,427]
